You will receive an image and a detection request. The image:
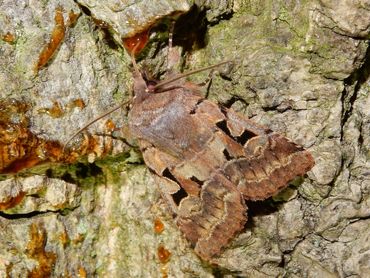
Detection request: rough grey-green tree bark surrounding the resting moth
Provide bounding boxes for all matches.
[0,0,370,277]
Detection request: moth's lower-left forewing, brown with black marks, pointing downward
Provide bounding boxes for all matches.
[143,140,247,260]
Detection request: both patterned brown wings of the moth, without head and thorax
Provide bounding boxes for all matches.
[136,94,314,260]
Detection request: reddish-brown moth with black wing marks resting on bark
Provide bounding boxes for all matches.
[128,35,314,261]
